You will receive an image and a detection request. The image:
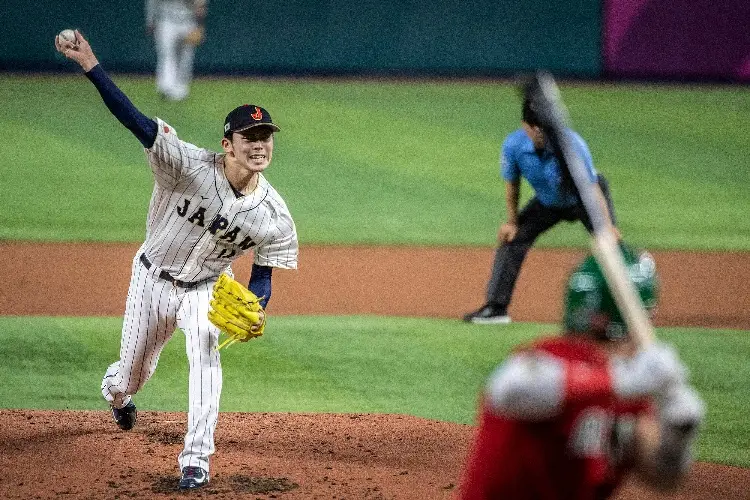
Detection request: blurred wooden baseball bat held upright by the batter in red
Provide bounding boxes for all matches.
[525,71,654,346]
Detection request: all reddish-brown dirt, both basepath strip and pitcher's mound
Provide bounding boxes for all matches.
[0,242,750,500]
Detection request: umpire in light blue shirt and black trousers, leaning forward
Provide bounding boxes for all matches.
[464,99,619,324]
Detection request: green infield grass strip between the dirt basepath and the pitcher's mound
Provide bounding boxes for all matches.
[0,316,750,467]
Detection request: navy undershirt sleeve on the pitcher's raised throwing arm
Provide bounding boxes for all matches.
[86,64,158,148]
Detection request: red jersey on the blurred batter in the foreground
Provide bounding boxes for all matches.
[459,337,648,500]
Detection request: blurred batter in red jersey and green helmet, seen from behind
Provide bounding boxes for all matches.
[458,244,704,500]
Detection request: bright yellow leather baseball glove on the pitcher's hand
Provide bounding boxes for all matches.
[208,273,266,349]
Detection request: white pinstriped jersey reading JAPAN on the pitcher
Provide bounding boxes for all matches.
[141,119,299,281]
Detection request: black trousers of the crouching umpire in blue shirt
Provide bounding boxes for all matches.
[487,175,617,308]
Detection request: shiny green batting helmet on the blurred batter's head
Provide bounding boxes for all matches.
[563,243,658,340]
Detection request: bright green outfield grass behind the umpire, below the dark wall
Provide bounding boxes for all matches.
[0,74,750,251]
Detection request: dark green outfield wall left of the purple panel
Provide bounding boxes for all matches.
[0,0,601,77]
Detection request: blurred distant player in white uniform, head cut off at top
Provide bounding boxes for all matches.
[146,0,208,101]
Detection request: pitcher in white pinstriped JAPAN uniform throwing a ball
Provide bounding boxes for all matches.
[55,31,298,489]
